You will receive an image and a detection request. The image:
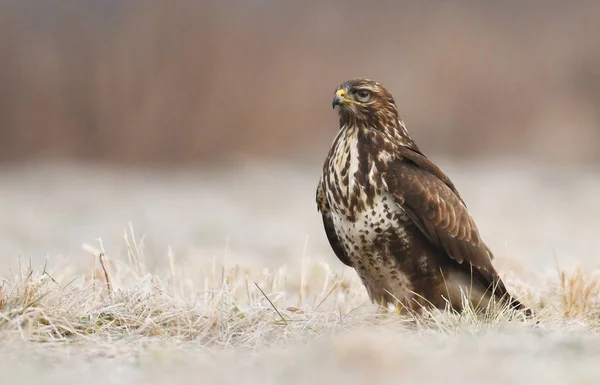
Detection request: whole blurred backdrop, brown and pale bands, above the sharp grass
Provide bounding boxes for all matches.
[0,0,600,284]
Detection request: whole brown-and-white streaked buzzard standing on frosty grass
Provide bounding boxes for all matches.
[316,79,532,315]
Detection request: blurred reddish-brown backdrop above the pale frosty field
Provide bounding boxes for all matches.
[0,0,600,164]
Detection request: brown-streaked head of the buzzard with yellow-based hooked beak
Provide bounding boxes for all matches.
[332,79,398,125]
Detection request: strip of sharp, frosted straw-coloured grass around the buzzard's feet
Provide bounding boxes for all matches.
[0,229,600,348]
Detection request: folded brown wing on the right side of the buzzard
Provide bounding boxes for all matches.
[384,150,506,295]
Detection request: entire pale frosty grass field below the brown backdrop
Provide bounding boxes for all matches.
[0,162,600,384]
